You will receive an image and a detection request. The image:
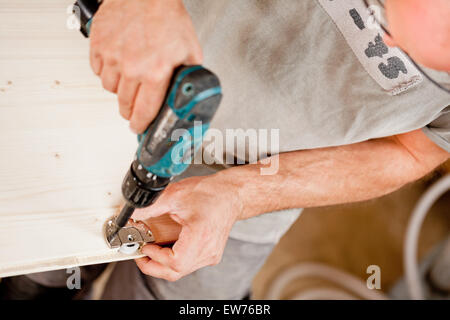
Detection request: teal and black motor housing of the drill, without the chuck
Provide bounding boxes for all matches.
[136,66,222,178]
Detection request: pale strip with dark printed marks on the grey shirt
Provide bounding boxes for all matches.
[318,0,423,95]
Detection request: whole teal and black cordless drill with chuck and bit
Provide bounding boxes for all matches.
[74,0,222,242]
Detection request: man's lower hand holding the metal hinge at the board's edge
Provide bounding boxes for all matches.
[133,174,241,281]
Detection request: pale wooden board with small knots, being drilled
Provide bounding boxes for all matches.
[0,0,179,277]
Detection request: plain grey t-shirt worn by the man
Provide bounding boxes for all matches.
[185,0,450,242]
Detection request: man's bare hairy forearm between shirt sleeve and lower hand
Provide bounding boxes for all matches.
[218,133,448,219]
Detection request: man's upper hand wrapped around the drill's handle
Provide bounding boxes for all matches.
[90,0,202,133]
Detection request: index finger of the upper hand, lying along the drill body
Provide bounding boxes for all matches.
[130,77,170,133]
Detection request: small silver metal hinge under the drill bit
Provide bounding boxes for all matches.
[103,216,155,254]
